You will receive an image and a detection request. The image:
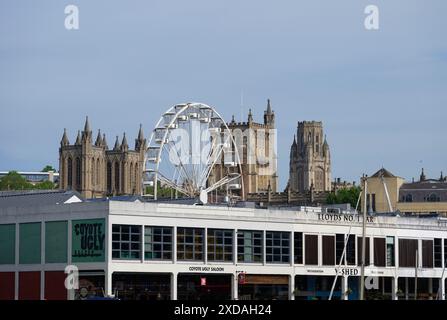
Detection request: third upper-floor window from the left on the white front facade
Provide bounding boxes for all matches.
[177,228,204,261]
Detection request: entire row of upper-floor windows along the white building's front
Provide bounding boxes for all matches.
[112,225,447,268]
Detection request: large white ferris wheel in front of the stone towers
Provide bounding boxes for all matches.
[142,102,244,203]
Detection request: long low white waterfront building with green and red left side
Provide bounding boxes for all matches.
[0,201,447,300]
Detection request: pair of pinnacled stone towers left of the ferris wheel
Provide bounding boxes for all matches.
[59,117,147,198]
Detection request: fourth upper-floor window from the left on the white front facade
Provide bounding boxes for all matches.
[207,229,233,261]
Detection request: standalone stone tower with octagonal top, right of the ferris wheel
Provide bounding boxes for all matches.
[289,121,331,192]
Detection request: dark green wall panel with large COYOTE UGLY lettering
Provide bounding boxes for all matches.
[71,219,106,262]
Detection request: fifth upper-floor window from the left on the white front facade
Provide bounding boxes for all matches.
[237,230,263,262]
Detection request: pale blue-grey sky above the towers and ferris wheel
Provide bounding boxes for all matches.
[0,0,447,188]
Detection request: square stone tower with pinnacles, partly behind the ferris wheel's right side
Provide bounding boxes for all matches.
[209,100,278,199]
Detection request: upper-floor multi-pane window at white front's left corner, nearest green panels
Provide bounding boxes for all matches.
[112,224,141,259]
